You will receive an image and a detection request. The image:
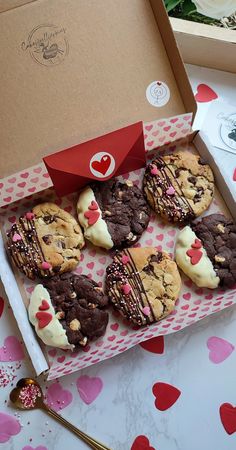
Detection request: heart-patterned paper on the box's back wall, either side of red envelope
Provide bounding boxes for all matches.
[0,114,192,207]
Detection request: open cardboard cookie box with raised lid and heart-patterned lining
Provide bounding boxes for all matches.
[0,0,235,379]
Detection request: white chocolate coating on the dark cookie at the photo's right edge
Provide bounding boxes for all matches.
[175,226,220,289]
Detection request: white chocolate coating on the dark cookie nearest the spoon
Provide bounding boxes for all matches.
[28,284,74,350]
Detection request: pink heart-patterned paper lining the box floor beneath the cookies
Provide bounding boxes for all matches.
[0,144,236,379]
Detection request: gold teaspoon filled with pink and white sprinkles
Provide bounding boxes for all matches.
[10,378,111,450]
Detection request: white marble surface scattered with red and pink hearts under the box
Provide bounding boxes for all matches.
[0,66,236,450]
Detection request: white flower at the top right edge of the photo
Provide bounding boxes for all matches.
[193,0,236,19]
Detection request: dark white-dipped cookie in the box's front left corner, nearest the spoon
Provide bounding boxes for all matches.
[28,273,108,350]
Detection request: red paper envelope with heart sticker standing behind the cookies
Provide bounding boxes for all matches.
[43,122,146,196]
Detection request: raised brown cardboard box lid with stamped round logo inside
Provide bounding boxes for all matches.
[0,0,196,178]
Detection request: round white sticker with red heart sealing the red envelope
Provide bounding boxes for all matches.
[89,152,116,178]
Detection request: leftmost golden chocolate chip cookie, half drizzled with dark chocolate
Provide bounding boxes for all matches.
[7,203,84,280]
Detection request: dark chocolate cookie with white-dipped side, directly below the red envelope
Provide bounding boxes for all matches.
[77,179,150,249]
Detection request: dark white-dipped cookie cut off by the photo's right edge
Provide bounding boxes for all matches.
[176,214,236,289]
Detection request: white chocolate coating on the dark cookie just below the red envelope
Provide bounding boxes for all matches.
[77,187,114,249]
